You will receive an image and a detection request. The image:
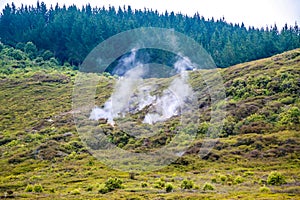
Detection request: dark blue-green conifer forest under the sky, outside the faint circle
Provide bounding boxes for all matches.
[0,2,300,67]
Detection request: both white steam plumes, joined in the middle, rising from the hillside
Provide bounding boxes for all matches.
[90,50,193,125]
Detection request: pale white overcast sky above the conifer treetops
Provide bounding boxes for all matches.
[0,0,300,28]
